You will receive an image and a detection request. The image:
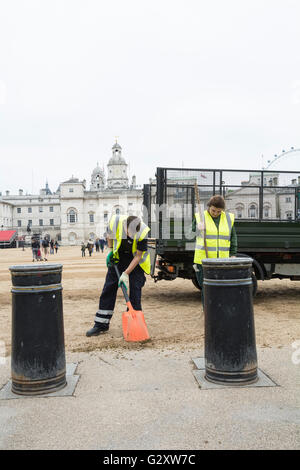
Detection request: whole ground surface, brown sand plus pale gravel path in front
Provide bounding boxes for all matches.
[0,247,300,450]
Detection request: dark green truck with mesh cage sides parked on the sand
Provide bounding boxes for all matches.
[143,167,300,295]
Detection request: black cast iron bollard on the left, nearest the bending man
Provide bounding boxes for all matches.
[9,264,67,395]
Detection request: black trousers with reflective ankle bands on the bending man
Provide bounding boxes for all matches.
[95,258,146,324]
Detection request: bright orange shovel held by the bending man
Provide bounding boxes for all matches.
[114,265,150,341]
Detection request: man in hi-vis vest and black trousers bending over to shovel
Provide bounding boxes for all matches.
[86,214,151,336]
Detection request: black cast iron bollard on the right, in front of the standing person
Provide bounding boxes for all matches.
[202,258,258,385]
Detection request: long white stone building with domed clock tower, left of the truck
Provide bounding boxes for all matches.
[0,142,142,245]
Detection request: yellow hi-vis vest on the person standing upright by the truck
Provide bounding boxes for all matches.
[194,211,234,264]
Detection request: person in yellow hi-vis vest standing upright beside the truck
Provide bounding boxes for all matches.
[192,196,237,303]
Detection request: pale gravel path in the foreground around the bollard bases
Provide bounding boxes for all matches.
[0,348,300,450]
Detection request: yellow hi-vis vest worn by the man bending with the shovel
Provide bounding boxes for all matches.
[109,215,151,274]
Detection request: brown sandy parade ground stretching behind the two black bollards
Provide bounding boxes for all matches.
[0,247,300,355]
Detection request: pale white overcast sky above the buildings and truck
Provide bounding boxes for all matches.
[0,0,300,193]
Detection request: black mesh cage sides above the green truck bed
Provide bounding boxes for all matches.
[144,167,300,224]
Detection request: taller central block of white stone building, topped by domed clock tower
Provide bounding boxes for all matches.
[60,143,142,245]
